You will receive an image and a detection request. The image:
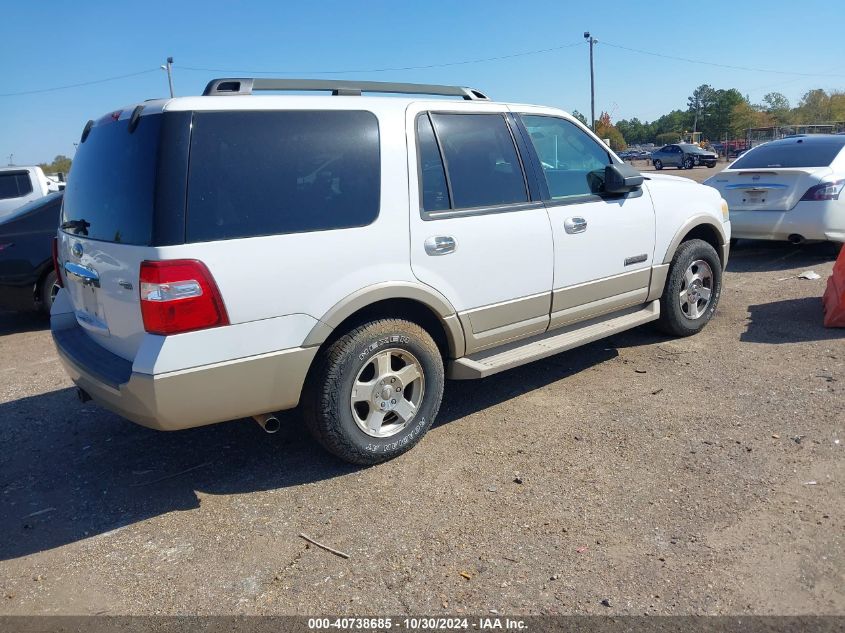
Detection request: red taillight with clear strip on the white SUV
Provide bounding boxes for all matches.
[140,259,229,335]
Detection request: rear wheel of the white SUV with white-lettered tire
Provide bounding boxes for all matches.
[303,319,445,466]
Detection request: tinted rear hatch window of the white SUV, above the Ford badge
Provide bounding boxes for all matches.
[62,115,161,245]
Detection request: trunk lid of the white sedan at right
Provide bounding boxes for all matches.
[707,167,833,211]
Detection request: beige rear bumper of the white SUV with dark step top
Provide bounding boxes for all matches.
[51,313,317,431]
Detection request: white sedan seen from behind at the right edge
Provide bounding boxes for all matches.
[705,134,845,243]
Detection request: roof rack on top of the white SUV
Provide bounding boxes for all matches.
[202,77,489,101]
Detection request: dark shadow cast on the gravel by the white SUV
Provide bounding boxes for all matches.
[0,341,617,560]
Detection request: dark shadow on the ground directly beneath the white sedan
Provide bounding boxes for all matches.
[728,240,841,273]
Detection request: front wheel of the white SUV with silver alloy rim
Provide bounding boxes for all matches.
[658,240,722,336]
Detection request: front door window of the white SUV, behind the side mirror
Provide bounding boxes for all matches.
[521,115,611,200]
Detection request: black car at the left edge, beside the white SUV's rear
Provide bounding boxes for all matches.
[0,193,63,314]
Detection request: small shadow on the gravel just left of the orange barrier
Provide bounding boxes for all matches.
[739,297,845,344]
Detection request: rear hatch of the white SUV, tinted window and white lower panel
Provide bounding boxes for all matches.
[59,108,188,360]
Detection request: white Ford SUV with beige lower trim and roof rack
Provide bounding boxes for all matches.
[52,79,730,464]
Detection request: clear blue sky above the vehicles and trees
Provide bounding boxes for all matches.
[0,0,845,165]
